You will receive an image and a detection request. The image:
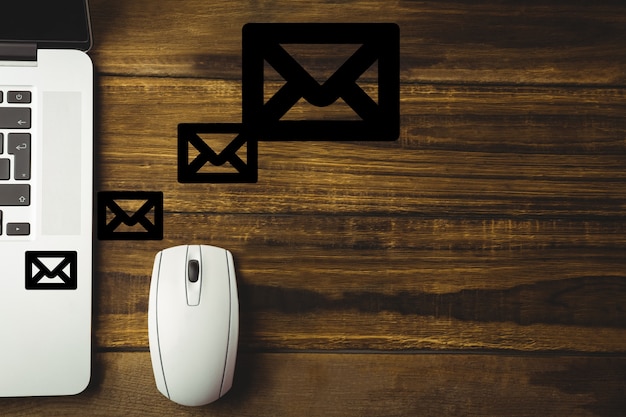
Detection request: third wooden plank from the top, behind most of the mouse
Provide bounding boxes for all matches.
[96,213,626,352]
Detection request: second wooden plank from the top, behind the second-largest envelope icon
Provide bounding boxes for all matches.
[98,77,626,218]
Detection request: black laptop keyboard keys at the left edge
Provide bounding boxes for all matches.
[0,86,33,240]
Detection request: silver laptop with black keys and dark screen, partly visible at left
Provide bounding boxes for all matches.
[0,0,93,397]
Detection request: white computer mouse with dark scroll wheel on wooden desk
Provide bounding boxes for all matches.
[148,245,239,406]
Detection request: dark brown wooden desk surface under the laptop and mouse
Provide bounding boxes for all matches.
[0,0,626,417]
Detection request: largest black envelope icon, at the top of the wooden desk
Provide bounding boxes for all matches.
[242,23,400,140]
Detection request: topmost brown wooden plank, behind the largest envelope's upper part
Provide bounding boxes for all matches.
[91,0,626,84]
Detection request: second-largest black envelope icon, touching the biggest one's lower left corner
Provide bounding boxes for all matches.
[178,123,258,183]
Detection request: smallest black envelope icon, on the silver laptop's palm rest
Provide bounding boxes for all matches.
[26,251,78,290]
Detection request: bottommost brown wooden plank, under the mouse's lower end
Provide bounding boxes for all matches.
[0,352,626,417]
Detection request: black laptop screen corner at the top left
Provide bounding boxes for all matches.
[0,0,91,50]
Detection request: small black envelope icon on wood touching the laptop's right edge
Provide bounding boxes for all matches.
[97,191,163,240]
